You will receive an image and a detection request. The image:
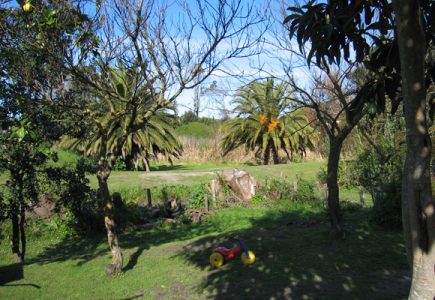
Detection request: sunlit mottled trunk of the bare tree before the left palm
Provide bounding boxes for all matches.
[97,168,123,275]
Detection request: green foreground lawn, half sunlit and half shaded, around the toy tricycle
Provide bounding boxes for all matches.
[0,205,409,299]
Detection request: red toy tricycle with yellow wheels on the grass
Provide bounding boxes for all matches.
[210,239,255,268]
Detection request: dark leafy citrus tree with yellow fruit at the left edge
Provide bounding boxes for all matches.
[0,1,94,262]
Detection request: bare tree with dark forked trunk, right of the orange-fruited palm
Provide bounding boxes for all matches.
[267,3,374,237]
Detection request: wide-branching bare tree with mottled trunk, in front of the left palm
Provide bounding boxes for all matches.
[59,0,265,274]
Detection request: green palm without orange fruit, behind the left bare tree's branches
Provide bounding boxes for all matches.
[61,66,182,171]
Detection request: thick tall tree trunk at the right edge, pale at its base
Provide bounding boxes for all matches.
[393,0,435,300]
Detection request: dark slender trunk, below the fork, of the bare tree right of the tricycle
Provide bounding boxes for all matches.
[326,136,344,235]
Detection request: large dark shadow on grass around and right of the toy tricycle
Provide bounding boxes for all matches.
[176,212,410,299]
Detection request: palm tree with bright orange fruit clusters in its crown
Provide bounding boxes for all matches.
[222,78,313,164]
